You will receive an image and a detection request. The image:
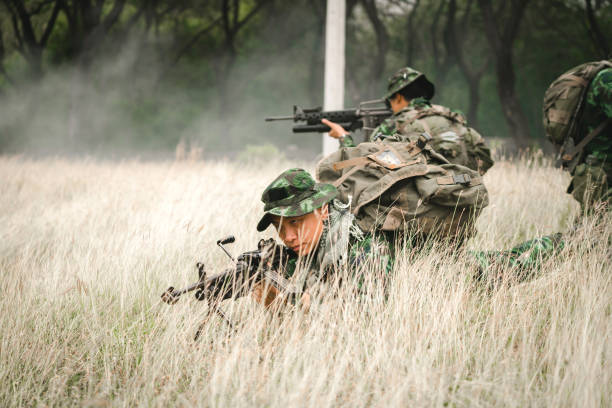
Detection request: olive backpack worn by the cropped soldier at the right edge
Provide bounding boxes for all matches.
[542,60,612,165]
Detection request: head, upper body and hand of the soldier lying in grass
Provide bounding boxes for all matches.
[253,169,393,305]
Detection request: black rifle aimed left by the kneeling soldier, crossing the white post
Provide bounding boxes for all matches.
[266,99,393,140]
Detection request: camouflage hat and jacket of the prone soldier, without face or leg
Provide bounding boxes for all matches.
[257,169,393,288]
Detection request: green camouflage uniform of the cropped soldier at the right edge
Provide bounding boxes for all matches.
[568,68,612,208]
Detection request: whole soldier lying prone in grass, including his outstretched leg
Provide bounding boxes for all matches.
[253,169,563,306]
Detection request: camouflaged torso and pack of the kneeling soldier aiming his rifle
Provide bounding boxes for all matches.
[341,98,493,174]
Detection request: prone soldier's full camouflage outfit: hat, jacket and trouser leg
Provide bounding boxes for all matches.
[257,169,564,289]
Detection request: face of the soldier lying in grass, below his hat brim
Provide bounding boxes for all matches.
[272,204,329,256]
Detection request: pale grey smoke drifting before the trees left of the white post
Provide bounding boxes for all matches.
[0,17,322,158]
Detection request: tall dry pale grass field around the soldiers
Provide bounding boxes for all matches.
[0,157,612,407]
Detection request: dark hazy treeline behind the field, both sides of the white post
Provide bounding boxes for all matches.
[0,0,612,153]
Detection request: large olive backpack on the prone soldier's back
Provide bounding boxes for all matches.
[316,133,489,239]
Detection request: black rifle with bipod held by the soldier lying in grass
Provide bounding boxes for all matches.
[161,235,300,340]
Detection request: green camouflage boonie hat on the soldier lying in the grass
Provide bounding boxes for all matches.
[257,169,338,231]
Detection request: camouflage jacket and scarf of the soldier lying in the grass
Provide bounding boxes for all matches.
[284,200,393,289]
